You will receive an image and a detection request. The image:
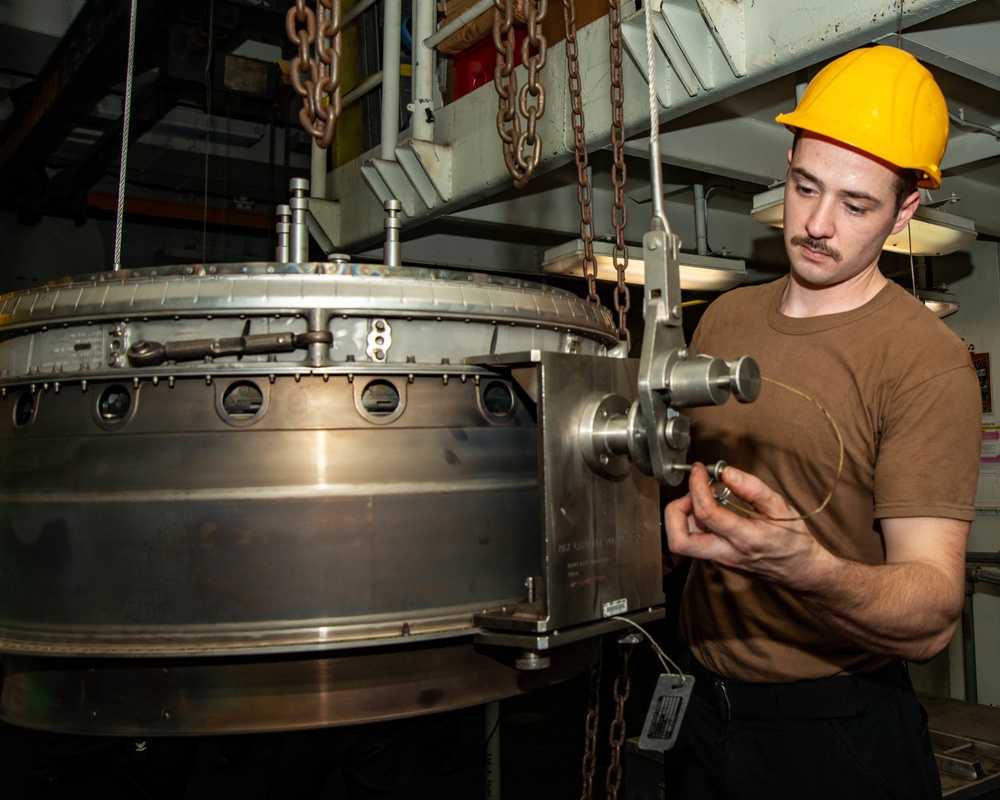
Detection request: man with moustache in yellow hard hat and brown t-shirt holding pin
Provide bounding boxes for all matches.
[665,47,981,800]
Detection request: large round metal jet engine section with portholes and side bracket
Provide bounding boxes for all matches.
[0,262,662,735]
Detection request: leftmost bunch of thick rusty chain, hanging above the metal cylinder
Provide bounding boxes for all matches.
[285,0,341,149]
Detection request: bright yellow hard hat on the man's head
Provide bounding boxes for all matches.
[776,45,948,189]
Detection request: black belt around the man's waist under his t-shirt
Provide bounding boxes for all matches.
[688,657,910,722]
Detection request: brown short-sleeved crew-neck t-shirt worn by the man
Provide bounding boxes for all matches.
[680,277,981,682]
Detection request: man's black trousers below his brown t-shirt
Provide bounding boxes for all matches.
[664,656,941,800]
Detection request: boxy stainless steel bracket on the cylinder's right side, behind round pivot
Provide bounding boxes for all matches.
[470,351,663,636]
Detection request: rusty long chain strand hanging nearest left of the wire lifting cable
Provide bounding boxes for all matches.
[608,0,632,352]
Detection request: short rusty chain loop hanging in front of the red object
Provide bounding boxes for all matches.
[493,0,548,189]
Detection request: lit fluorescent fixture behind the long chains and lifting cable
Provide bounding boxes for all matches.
[542,239,747,292]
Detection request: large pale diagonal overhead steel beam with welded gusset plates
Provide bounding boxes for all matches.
[318,0,973,251]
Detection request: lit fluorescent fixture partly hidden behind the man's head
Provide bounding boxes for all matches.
[750,186,976,256]
